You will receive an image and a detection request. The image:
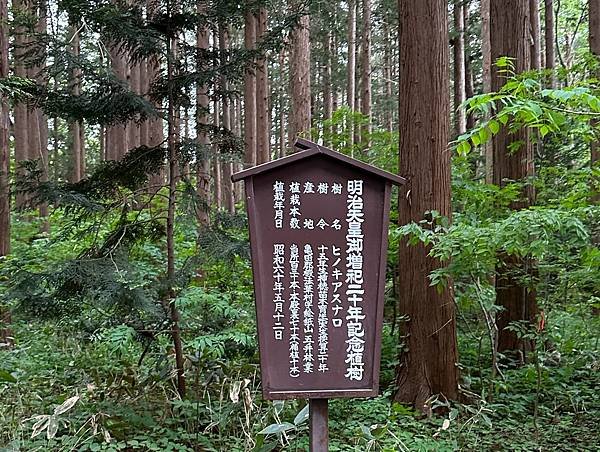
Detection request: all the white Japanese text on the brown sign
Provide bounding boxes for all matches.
[272,179,365,381]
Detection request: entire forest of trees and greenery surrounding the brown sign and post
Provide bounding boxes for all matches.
[0,0,600,451]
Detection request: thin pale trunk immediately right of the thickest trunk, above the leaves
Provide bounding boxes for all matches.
[452,0,466,136]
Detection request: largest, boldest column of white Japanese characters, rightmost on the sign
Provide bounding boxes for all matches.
[345,180,365,381]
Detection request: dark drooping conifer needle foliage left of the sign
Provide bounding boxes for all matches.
[8,0,302,354]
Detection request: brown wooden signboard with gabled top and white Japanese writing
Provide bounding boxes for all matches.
[233,140,403,399]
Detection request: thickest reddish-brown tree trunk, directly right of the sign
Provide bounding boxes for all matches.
[394,0,458,412]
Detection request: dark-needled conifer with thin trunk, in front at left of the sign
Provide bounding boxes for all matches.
[6,0,289,397]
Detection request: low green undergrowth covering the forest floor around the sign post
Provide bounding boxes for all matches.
[0,312,600,452]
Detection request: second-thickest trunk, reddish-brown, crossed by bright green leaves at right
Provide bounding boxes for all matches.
[490,0,537,357]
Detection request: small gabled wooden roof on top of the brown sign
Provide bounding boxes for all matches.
[231,138,406,185]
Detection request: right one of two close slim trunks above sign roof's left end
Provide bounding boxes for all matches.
[256,7,271,164]
